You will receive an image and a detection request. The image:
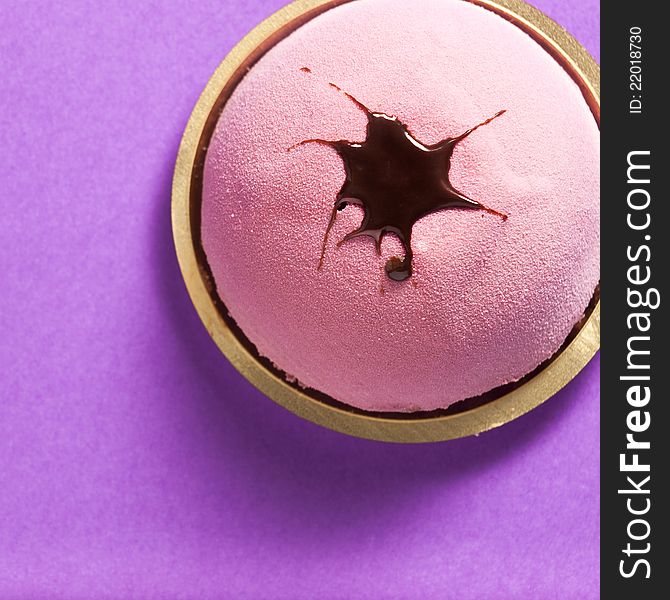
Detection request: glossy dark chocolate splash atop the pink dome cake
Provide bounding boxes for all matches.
[290,72,507,281]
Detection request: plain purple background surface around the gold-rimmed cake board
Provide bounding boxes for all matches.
[0,0,599,600]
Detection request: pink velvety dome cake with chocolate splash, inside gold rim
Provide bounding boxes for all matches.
[201,0,600,412]
